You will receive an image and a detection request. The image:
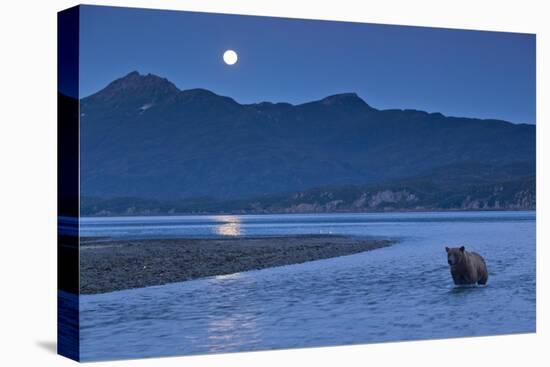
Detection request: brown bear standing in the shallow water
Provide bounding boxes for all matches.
[445,246,489,285]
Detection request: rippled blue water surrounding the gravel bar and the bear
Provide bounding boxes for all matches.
[80,212,536,360]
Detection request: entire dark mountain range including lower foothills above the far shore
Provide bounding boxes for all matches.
[80,72,535,215]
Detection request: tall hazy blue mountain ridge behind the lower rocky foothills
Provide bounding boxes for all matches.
[80,72,535,208]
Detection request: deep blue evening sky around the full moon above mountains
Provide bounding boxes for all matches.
[80,6,536,123]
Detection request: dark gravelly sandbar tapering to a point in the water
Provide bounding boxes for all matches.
[80,235,394,294]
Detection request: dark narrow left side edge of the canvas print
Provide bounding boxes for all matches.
[57,7,80,360]
